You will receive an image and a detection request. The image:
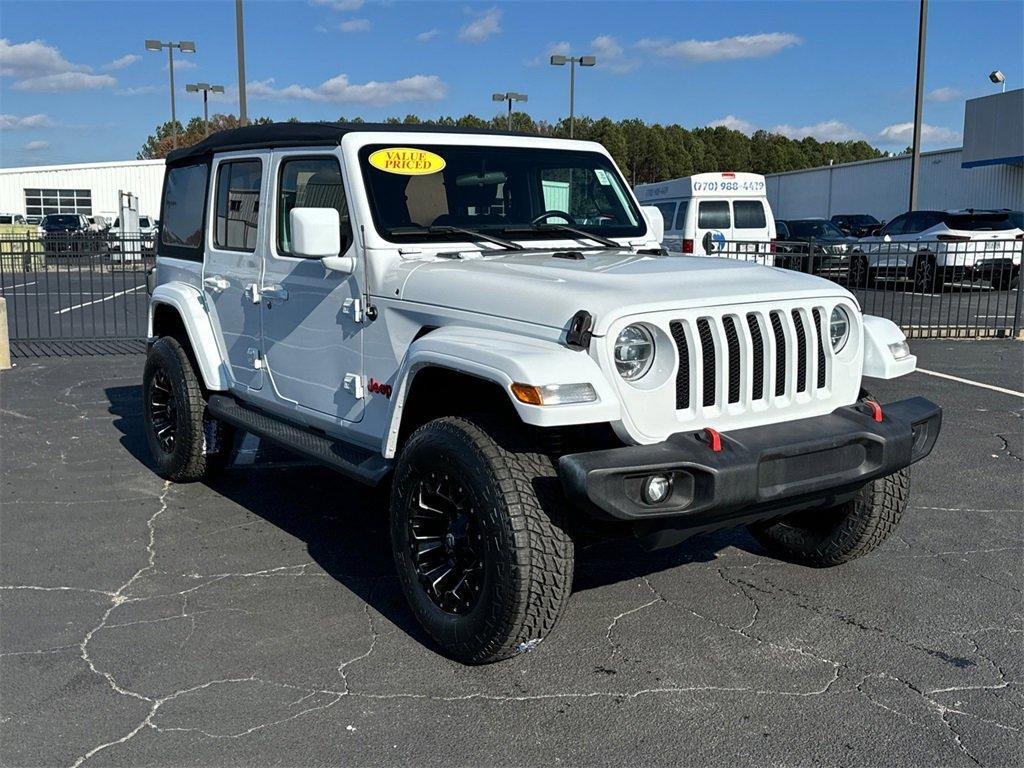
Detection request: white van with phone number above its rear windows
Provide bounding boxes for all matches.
[636,171,775,263]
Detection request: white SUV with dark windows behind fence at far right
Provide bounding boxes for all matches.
[850,209,1024,293]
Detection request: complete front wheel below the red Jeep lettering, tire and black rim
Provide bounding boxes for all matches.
[391,417,573,664]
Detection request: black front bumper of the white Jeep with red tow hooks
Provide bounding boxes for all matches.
[558,397,942,527]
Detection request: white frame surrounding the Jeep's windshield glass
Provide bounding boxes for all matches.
[356,139,650,250]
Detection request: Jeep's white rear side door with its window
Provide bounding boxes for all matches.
[203,153,270,389]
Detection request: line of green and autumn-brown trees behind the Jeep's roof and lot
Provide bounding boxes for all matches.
[138,112,886,184]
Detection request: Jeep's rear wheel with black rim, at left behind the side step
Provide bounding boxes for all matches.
[142,336,231,482]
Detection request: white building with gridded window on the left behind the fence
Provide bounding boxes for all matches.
[0,160,164,222]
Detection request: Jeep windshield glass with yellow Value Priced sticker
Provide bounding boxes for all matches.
[359,144,646,242]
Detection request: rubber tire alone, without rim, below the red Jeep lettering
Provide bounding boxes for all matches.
[390,417,573,664]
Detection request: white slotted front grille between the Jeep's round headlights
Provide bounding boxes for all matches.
[669,307,831,413]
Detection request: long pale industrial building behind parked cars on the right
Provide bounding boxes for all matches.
[765,89,1024,221]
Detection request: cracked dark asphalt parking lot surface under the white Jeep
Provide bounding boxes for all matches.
[0,341,1024,766]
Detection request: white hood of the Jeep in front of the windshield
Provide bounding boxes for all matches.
[401,251,850,335]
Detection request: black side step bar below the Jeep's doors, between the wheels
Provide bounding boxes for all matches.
[207,394,390,485]
